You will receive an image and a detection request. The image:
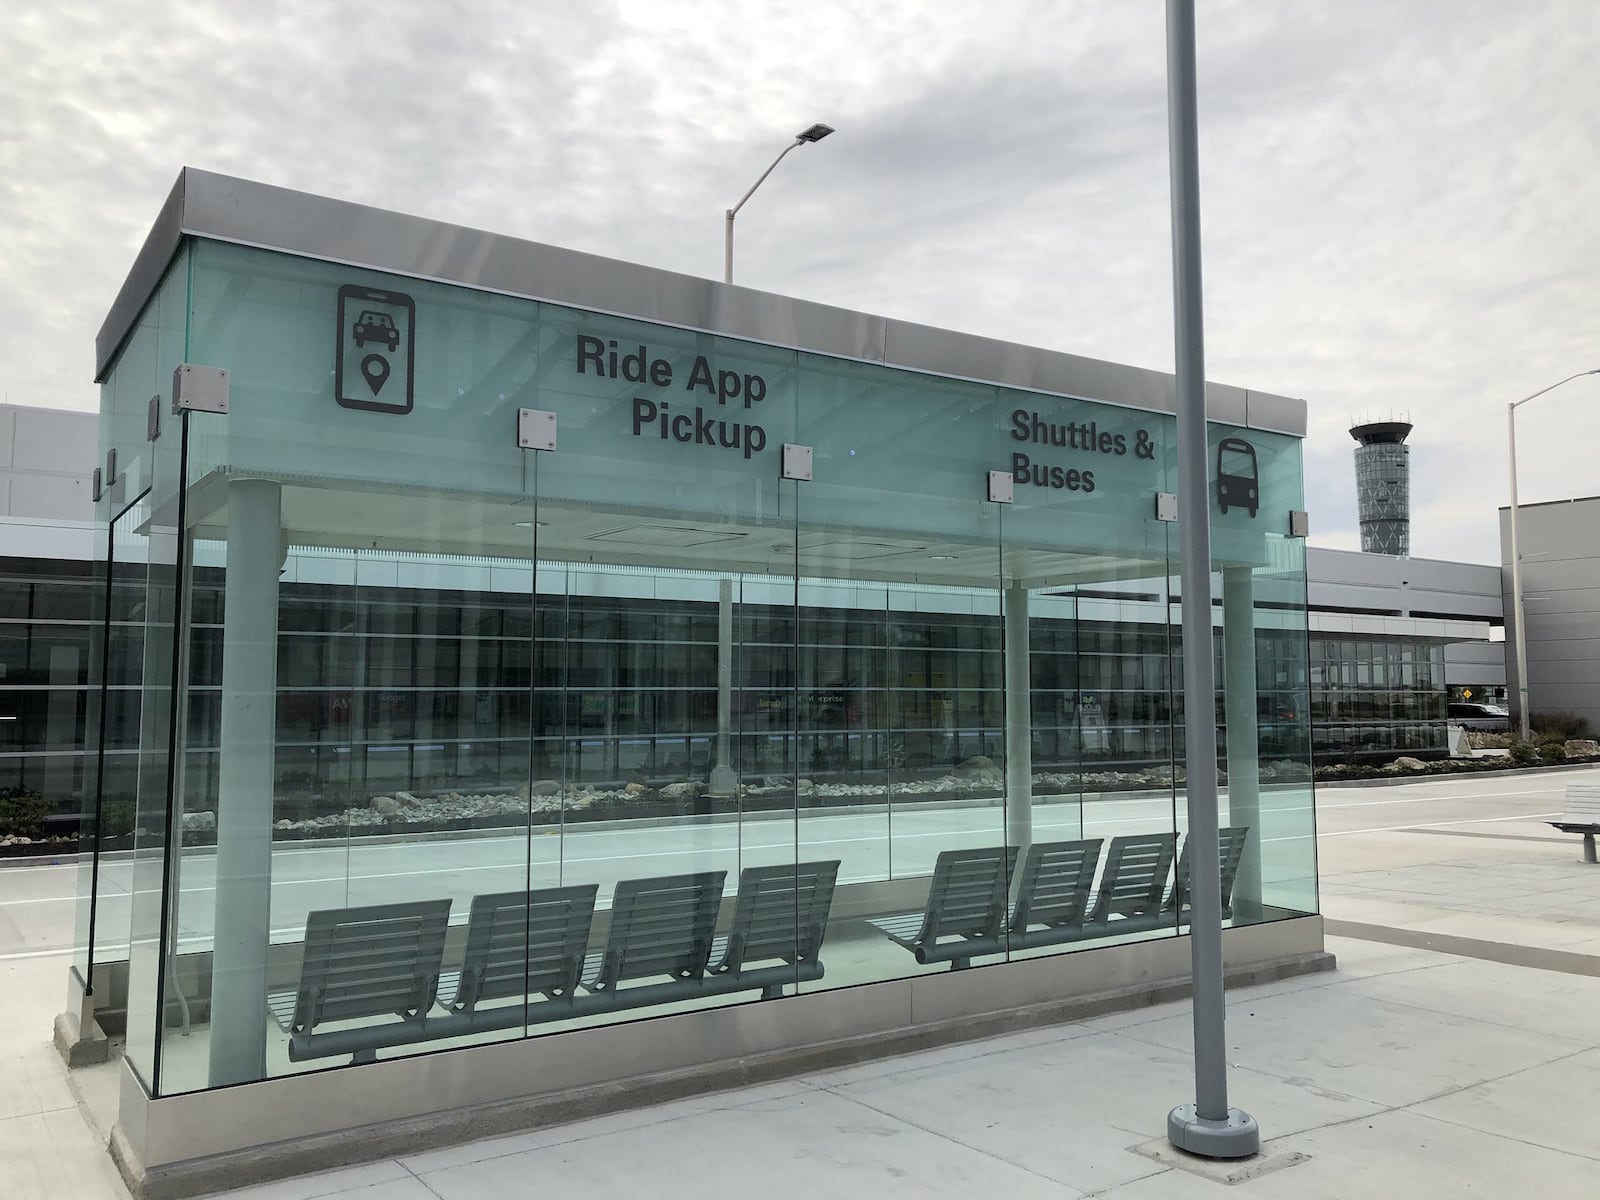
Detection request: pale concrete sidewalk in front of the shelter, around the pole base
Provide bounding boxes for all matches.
[175,939,1600,1200]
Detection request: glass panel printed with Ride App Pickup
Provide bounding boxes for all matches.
[528,306,800,1034]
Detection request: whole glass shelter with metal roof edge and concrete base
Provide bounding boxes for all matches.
[74,171,1322,1190]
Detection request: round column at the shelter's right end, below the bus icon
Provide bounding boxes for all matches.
[1222,566,1262,920]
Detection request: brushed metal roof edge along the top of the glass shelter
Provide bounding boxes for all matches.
[96,166,1306,437]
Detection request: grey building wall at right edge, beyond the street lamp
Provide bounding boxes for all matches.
[1499,496,1600,730]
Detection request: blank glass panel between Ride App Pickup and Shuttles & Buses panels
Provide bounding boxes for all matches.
[795,355,1006,989]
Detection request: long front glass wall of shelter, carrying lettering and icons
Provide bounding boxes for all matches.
[81,235,1315,1094]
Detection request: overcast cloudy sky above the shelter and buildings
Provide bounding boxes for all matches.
[0,0,1600,562]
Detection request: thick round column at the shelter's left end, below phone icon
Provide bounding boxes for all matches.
[210,478,283,1088]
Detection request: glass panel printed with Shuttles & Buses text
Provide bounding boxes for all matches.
[1002,392,1181,957]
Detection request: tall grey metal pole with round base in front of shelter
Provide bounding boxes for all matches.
[1166,0,1261,1158]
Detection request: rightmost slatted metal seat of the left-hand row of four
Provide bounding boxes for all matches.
[707,859,838,1000]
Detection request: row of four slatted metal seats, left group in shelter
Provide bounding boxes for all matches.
[270,859,838,1062]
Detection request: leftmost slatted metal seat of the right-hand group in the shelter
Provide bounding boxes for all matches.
[869,846,1016,971]
